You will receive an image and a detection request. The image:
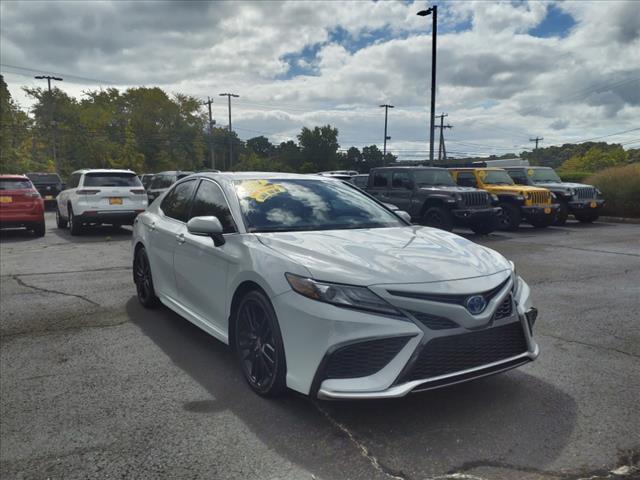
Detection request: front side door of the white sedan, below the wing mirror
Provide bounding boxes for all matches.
[173,179,239,335]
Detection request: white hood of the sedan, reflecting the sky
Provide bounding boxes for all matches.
[255,226,510,285]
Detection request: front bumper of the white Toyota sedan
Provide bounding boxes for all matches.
[272,272,539,399]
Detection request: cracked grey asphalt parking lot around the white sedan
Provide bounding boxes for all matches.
[0,213,640,480]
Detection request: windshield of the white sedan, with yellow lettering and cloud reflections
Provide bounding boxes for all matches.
[234,179,405,232]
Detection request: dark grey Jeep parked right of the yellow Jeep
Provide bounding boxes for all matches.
[504,167,605,225]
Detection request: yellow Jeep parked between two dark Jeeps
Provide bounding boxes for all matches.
[449,167,558,230]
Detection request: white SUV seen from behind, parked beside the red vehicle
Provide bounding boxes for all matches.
[56,169,148,235]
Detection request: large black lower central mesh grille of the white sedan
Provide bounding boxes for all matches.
[400,322,527,381]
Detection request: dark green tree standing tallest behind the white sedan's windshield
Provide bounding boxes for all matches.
[298,125,340,172]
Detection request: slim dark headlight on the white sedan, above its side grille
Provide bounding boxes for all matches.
[284,273,403,316]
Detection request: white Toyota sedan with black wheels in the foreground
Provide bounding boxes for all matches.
[133,173,538,399]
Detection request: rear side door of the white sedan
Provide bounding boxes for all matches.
[147,179,197,301]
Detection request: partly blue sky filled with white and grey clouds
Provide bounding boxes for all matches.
[0,0,640,160]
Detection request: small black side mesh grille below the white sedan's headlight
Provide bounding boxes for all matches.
[324,337,411,378]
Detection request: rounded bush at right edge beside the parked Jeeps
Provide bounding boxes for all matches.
[585,163,640,218]
